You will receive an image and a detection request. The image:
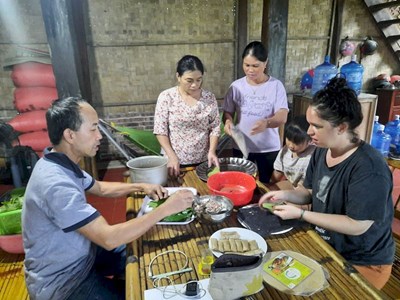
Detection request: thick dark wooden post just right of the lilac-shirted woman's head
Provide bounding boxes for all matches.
[261,0,289,84]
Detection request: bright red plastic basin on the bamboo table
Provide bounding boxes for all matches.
[207,171,256,206]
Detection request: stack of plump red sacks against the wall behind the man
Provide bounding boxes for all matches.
[8,62,58,156]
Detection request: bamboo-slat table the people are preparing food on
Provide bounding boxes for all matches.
[126,171,386,300]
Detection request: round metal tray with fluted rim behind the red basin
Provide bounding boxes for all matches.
[196,157,258,181]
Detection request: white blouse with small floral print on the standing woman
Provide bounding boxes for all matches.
[153,86,220,165]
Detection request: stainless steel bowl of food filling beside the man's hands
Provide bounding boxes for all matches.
[193,195,233,223]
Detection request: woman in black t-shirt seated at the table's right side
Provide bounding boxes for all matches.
[259,78,394,289]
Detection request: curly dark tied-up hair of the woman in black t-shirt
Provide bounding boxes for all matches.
[311,77,363,143]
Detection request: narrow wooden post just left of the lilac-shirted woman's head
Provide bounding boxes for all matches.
[235,0,249,78]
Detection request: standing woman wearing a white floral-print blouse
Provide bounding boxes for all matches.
[153,55,220,176]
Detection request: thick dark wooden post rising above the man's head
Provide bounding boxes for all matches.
[41,0,91,102]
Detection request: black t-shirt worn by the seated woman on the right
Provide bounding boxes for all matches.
[304,142,394,265]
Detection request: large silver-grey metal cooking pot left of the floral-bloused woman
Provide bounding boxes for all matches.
[126,156,168,185]
